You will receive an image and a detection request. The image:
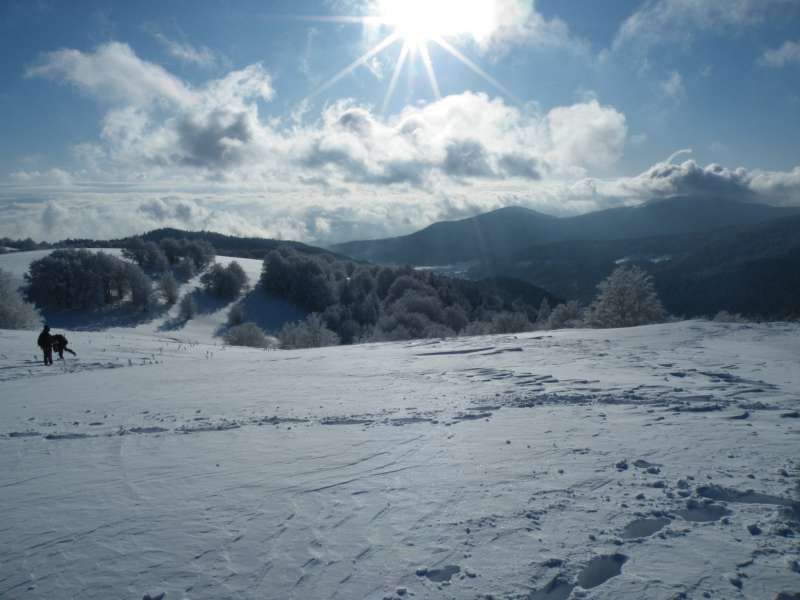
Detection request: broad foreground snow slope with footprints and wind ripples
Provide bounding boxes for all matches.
[0,322,800,600]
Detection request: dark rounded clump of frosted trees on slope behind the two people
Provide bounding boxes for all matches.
[25,250,153,309]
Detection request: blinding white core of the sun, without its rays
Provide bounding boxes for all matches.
[375,0,496,47]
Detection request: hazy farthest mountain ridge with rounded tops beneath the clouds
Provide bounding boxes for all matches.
[331,197,800,265]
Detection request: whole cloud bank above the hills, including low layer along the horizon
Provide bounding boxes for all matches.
[0,42,800,244]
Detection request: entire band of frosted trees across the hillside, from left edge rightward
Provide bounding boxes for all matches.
[0,238,684,348]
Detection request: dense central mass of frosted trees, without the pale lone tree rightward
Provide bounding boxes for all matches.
[261,247,555,347]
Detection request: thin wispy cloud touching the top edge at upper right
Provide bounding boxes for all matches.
[613,0,794,49]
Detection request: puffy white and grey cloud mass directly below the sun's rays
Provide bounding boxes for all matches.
[294,92,627,186]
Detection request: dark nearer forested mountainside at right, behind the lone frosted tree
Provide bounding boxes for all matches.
[468,216,800,317]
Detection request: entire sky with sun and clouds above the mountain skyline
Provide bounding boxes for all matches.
[0,0,800,244]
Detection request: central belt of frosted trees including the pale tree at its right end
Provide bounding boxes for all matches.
[261,248,666,348]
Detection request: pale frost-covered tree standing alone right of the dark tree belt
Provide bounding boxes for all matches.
[587,265,666,327]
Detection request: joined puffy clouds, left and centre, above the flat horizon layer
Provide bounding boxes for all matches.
[26,43,627,187]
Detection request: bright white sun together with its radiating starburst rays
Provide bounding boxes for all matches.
[304,0,519,113]
